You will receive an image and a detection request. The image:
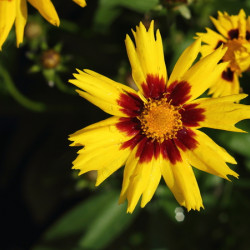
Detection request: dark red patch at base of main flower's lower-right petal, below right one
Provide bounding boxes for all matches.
[174,128,198,151]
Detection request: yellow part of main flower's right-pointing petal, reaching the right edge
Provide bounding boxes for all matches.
[196,94,250,132]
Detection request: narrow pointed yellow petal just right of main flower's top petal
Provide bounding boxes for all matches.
[168,39,201,85]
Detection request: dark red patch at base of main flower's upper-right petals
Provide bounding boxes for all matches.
[167,81,191,106]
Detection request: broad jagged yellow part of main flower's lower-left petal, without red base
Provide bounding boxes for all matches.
[69,117,130,178]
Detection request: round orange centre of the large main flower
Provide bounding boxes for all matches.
[138,97,182,142]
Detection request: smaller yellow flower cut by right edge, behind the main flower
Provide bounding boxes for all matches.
[197,10,250,97]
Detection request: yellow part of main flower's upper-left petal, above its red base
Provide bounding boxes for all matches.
[69,70,137,116]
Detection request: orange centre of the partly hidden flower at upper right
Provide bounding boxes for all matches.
[223,39,249,74]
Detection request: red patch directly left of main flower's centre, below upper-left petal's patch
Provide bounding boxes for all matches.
[116,117,141,136]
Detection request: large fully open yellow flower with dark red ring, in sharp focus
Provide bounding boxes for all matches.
[70,22,250,213]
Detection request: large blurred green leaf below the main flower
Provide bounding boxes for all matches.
[34,191,136,250]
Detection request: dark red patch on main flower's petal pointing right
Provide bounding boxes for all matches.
[179,104,205,127]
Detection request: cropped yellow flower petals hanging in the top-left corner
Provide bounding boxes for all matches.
[0,0,86,50]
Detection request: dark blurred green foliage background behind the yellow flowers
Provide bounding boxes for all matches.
[0,0,250,250]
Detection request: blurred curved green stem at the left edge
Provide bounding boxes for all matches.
[0,66,45,112]
